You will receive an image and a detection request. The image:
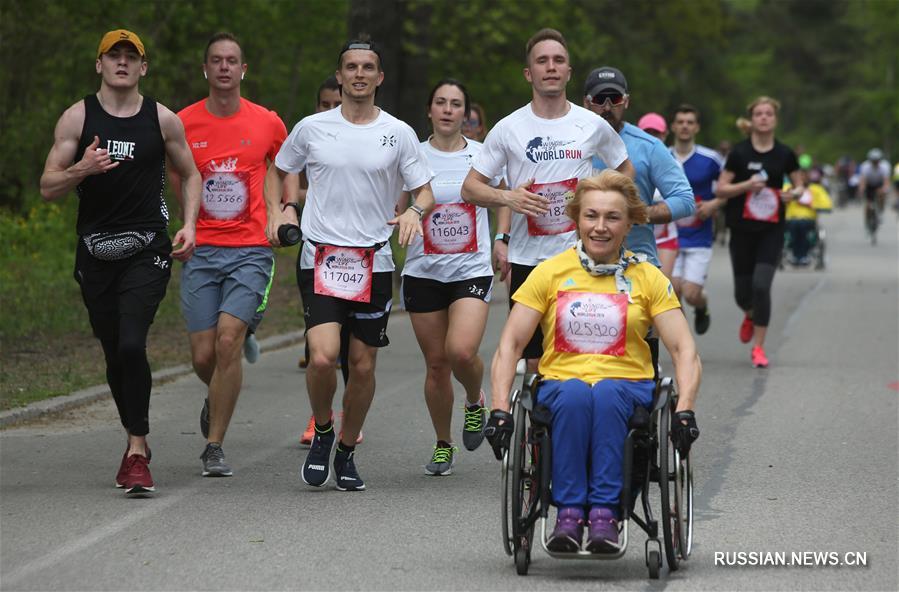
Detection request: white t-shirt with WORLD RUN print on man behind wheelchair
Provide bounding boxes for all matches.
[472,102,627,266]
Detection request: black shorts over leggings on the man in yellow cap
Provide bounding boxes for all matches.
[74,231,172,337]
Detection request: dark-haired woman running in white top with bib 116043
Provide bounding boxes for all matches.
[402,79,502,475]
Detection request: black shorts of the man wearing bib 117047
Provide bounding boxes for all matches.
[297,269,393,347]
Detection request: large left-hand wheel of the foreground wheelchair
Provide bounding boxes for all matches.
[509,404,540,575]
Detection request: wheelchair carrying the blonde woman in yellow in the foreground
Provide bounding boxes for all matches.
[502,374,693,579]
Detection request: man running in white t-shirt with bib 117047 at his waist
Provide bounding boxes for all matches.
[265,41,434,491]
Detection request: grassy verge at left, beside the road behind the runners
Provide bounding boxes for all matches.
[0,200,303,410]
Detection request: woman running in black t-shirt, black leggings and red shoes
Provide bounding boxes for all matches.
[715,96,805,368]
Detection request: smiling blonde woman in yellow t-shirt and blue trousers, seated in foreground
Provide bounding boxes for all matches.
[486,170,701,553]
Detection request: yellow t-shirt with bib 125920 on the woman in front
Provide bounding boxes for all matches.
[512,248,680,384]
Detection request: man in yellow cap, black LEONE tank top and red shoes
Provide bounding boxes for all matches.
[41,29,201,496]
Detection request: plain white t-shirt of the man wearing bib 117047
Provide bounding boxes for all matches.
[275,109,434,272]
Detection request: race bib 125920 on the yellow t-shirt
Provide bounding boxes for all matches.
[555,292,627,356]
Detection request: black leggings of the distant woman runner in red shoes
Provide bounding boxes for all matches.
[730,224,784,327]
